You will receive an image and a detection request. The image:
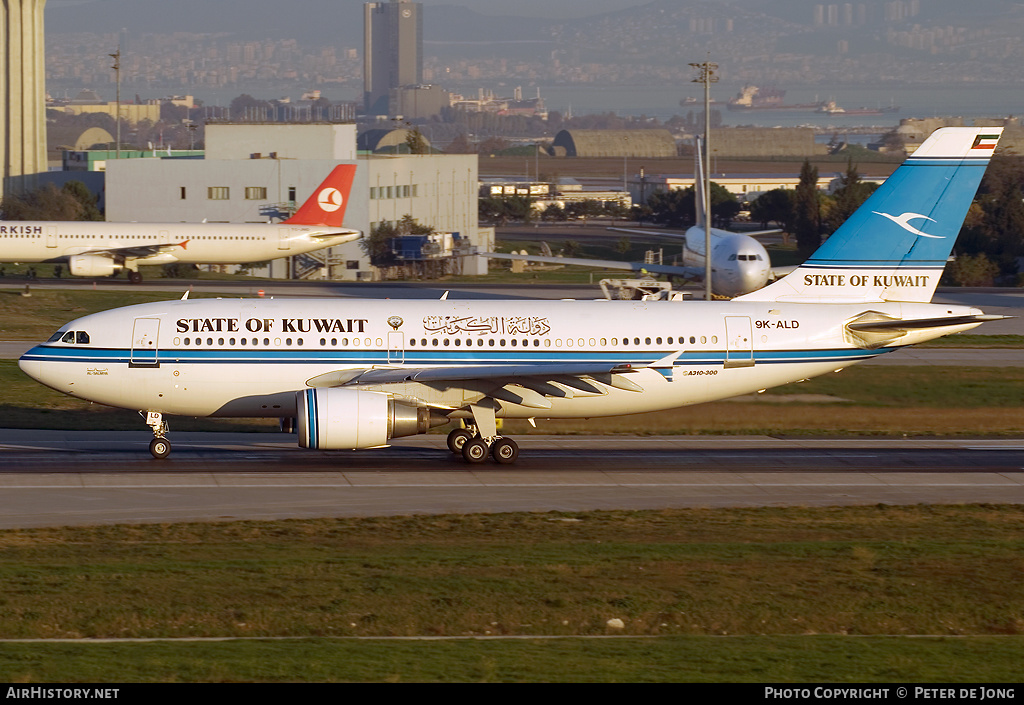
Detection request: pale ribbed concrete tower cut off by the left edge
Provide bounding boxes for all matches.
[0,0,46,192]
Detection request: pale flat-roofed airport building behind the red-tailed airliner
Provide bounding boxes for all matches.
[105,123,494,281]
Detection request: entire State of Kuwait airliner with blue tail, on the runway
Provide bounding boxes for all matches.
[19,127,1004,463]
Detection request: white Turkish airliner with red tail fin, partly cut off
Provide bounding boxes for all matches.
[0,164,361,284]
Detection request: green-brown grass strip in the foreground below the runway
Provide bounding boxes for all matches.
[0,506,1024,682]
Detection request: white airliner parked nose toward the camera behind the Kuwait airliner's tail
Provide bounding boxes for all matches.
[484,150,782,298]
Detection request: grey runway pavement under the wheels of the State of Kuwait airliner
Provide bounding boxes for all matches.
[0,429,1024,528]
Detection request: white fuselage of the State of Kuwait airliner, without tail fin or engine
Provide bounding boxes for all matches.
[19,299,979,418]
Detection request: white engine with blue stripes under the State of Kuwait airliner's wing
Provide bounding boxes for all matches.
[296,387,449,450]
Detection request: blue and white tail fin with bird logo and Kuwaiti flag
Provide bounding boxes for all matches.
[740,127,1002,302]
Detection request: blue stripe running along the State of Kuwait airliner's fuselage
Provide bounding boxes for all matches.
[23,346,898,367]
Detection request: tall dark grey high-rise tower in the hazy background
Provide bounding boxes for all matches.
[362,0,423,115]
